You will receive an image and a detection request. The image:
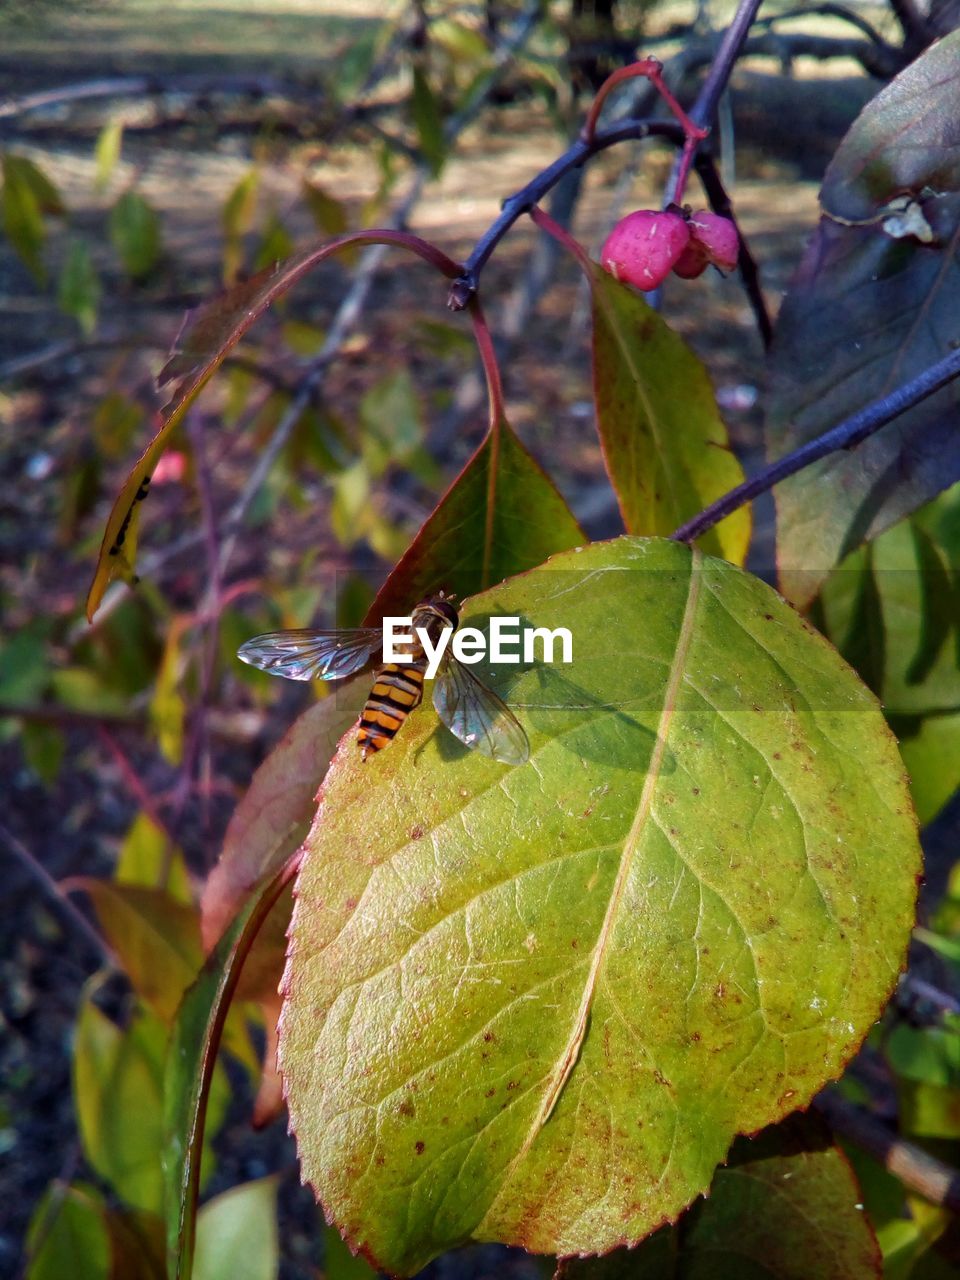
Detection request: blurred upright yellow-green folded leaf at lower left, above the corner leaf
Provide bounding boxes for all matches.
[73,991,166,1212]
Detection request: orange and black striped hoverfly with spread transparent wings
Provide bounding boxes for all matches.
[237,591,530,764]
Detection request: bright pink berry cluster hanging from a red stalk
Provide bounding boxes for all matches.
[600,206,740,291]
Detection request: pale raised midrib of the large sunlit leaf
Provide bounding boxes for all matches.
[488,548,703,1215]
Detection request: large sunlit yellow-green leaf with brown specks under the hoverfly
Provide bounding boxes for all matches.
[280,538,920,1275]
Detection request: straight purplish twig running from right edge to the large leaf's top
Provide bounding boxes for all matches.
[671,351,960,543]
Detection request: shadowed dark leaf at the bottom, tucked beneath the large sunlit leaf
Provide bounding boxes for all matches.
[558,1117,882,1280]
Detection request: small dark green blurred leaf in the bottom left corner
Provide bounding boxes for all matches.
[24,1183,113,1280]
